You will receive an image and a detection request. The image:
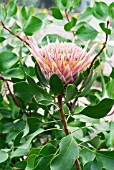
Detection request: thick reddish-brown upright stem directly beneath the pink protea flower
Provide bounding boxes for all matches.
[58,94,81,170]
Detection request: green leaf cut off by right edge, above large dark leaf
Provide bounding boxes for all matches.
[106,78,114,99]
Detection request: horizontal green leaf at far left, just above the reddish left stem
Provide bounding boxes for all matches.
[3,68,24,79]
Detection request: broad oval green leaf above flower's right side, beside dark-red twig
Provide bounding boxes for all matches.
[76,25,98,41]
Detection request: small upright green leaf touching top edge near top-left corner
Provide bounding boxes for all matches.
[7,0,17,17]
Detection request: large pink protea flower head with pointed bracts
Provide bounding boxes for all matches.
[29,39,97,85]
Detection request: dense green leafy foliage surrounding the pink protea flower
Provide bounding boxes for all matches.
[0,0,114,170]
